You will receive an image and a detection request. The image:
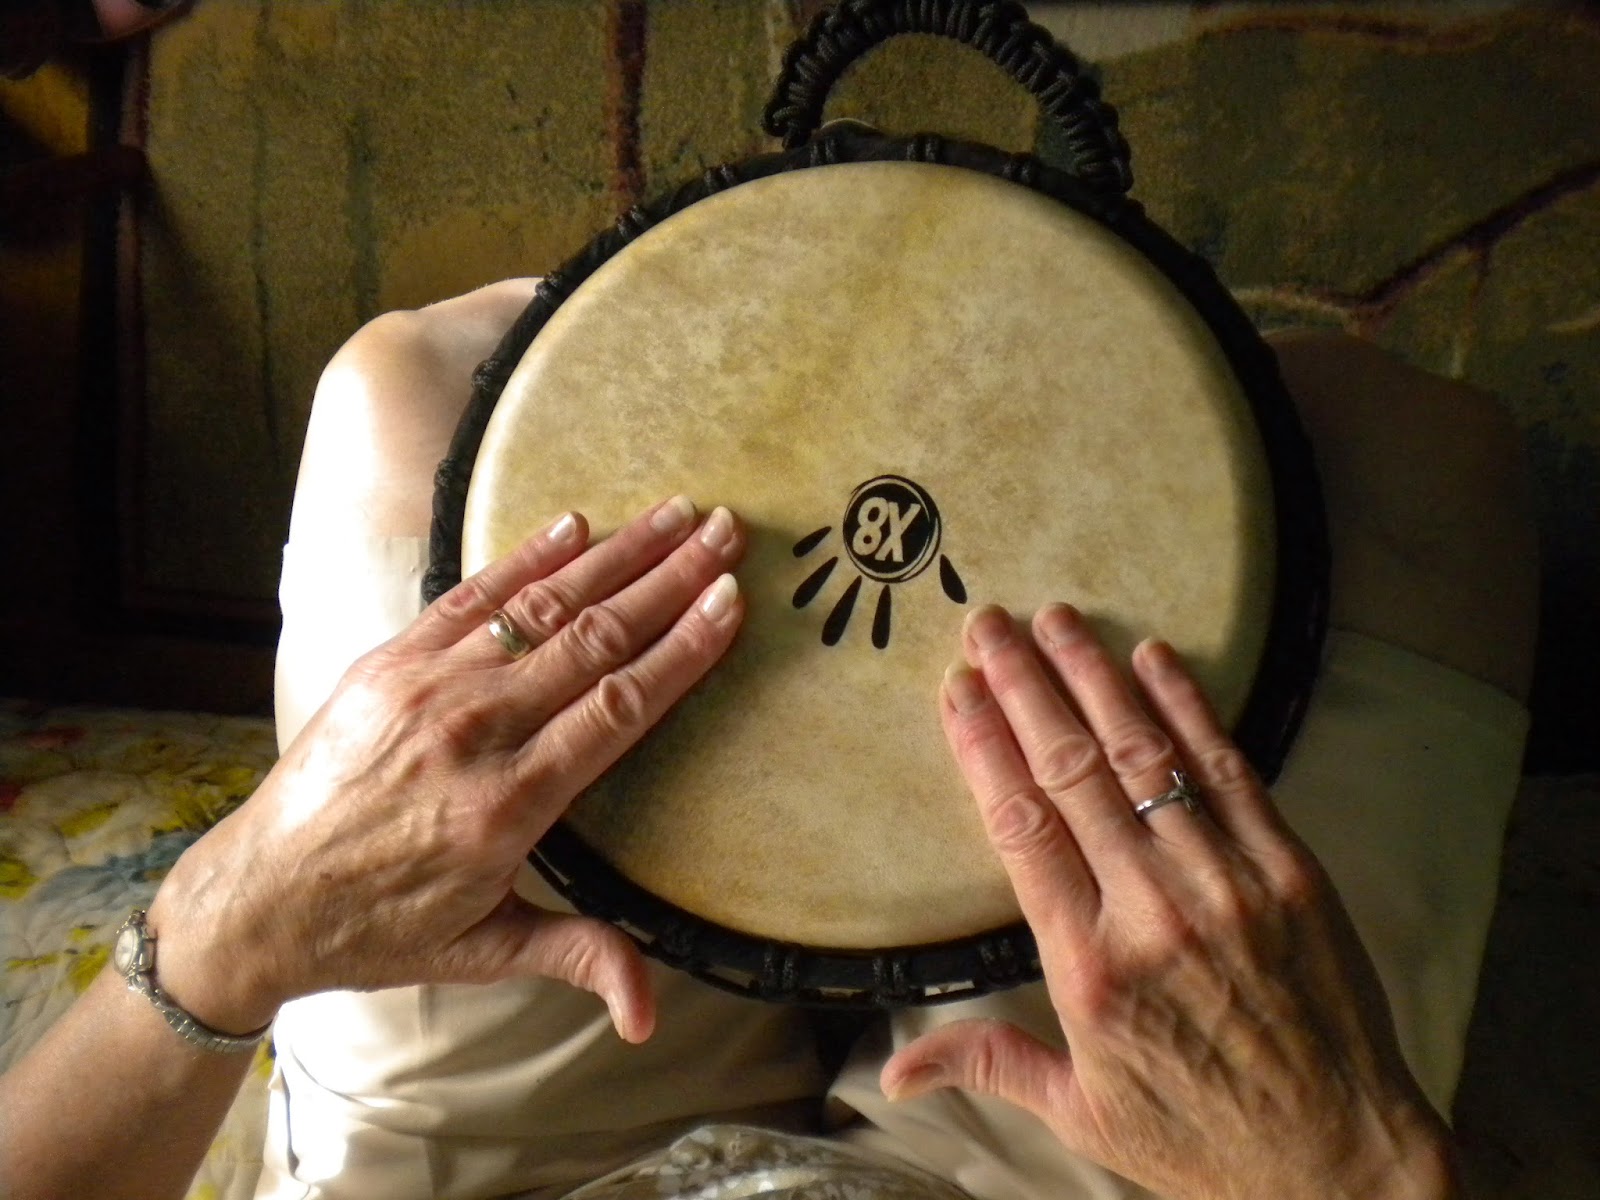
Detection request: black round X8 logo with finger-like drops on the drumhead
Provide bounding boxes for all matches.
[794,475,966,650]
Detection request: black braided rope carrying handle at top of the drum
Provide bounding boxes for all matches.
[762,0,1133,195]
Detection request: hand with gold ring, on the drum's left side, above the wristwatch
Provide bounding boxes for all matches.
[150,498,744,1042]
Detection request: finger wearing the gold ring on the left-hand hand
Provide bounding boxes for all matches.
[462,496,712,667]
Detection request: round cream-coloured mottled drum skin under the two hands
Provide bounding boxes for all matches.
[461,162,1275,950]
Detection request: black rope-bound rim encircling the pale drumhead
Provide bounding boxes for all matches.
[422,125,1330,1008]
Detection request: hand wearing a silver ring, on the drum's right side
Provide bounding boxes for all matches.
[882,605,1451,1200]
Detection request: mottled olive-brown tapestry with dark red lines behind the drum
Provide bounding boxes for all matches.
[125,0,1600,770]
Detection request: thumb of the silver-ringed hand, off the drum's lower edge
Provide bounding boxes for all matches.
[878,1019,1072,1117]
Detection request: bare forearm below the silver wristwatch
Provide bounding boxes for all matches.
[0,970,253,1200]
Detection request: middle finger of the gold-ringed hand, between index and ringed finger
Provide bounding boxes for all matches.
[512,507,744,726]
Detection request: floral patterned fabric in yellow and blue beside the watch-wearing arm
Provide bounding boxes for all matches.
[0,701,277,1200]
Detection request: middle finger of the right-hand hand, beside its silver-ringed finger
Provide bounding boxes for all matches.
[963,606,1142,874]
